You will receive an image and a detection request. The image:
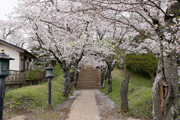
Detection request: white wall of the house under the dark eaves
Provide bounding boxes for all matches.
[0,44,20,71]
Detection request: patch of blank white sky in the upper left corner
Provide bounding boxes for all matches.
[0,0,18,20]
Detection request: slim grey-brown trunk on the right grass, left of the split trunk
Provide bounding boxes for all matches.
[120,73,130,112]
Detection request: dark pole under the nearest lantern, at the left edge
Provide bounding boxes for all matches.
[0,78,5,120]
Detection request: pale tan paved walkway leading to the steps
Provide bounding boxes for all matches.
[67,90,98,120]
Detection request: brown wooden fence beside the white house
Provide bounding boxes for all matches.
[5,70,47,89]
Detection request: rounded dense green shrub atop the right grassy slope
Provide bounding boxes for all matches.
[126,53,158,77]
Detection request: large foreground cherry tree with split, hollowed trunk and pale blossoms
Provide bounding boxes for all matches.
[77,0,180,120]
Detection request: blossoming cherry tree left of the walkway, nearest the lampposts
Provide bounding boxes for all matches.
[16,0,94,97]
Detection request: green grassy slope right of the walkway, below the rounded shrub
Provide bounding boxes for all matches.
[101,69,152,118]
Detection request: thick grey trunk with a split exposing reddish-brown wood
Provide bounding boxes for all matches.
[152,54,179,120]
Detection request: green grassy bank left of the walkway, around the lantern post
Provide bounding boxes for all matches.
[5,66,66,111]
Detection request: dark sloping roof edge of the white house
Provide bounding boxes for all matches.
[0,39,36,59]
